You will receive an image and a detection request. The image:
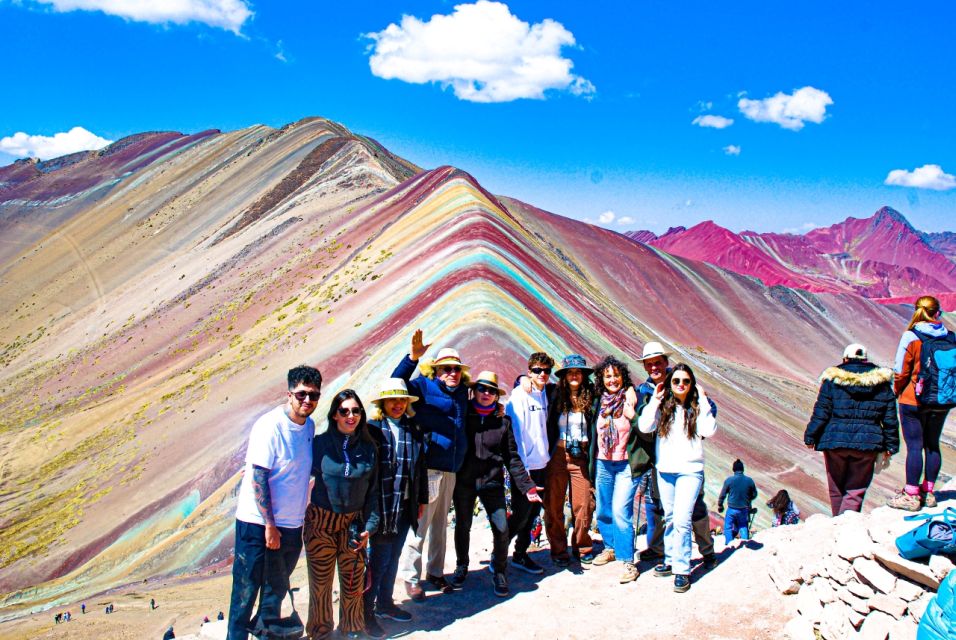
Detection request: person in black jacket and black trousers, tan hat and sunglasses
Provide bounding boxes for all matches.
[451,371,541,598]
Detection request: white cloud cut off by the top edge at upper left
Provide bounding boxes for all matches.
[33,0,253,35]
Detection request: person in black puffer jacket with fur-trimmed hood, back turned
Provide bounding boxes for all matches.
[803,343,900,516]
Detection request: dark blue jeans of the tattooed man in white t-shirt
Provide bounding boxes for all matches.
[226,520,302,640]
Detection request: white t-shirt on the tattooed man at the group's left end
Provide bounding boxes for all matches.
[236,405,315,529]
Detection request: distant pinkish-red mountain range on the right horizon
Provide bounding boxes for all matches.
[624,207,956,309]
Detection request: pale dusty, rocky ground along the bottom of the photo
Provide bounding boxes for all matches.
[0,493,956,640]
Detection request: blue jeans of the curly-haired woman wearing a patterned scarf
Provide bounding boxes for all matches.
[594,460,640,562]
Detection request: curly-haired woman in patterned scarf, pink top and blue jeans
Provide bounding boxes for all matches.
[588,356,640,584]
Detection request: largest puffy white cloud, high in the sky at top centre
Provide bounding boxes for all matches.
[365,0,595,102]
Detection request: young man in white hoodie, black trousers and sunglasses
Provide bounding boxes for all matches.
[505,352,556,574]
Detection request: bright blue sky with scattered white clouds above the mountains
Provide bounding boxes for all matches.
[0,0,956,232]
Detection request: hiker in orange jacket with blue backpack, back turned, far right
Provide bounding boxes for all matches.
[888,296,956,511]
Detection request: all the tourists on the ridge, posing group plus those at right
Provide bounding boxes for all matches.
[228,298,956,640]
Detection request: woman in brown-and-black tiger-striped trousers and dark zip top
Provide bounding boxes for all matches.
[305,389,381,638]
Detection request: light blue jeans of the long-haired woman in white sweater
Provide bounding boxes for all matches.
[657,471,704,576]
